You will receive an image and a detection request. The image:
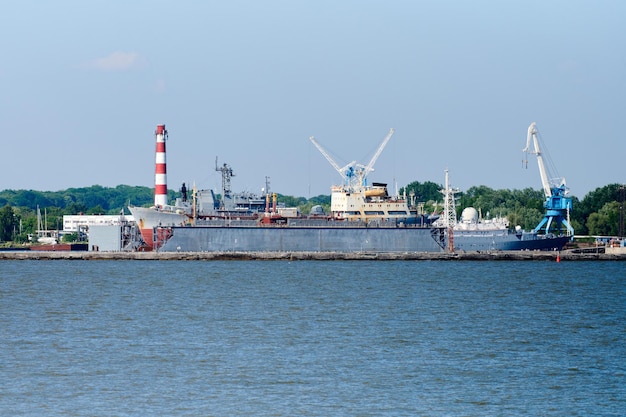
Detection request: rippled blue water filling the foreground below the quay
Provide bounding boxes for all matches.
[0,261,626,416]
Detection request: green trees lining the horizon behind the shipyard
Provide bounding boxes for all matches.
[0,181,624,242]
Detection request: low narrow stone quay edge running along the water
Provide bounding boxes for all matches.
[0,251,626,262]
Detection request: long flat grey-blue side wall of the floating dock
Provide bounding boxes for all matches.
[158,226,445,252]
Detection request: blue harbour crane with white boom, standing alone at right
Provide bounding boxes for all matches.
[522,122,574,237]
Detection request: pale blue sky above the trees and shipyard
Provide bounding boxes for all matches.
[0,0,626,199]
